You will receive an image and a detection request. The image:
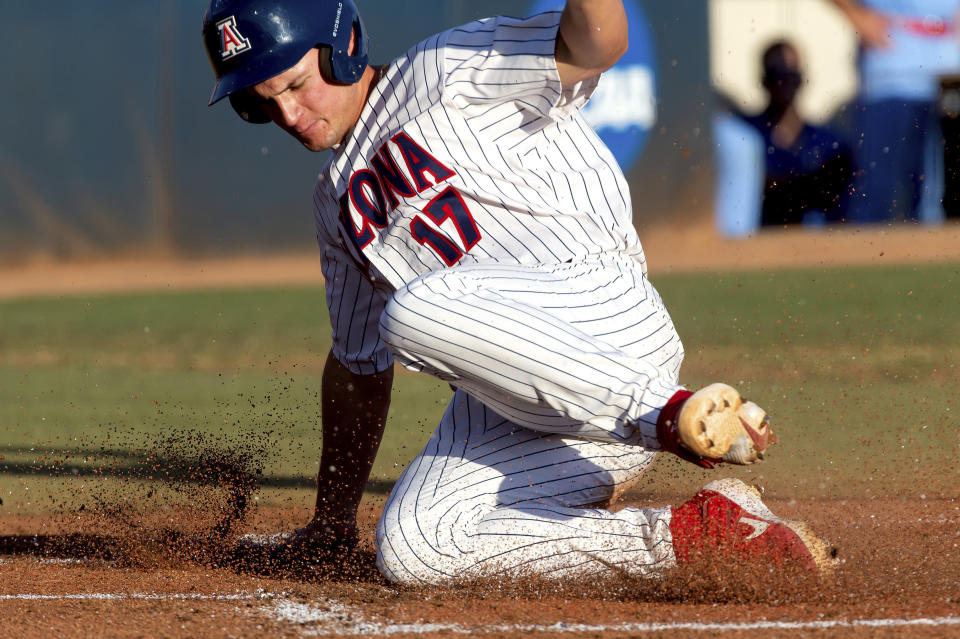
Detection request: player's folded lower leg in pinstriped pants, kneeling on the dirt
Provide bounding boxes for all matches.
[377,390,674,583]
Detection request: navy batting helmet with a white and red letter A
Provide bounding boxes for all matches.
[203,0,367,123]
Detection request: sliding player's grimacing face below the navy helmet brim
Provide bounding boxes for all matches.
[250,48,364,151]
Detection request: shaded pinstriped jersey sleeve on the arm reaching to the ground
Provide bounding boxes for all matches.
[314,178,393,375]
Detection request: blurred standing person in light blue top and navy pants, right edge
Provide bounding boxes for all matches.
[831,0,960,224]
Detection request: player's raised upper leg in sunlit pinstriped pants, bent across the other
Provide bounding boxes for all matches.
[381,256,683,449]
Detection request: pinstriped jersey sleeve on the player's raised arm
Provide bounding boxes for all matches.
[442,11,600,141]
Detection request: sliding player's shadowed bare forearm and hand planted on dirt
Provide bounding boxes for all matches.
[290,353,393,550]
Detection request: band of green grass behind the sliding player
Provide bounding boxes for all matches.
[0,265,960,513]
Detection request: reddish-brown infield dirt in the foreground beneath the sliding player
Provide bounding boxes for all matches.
[0,492,960,638]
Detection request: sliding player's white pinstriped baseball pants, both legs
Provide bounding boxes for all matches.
[377,254,683,583]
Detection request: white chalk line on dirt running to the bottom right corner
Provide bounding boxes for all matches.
[270,599,960,637]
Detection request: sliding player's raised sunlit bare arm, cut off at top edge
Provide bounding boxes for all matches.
[555,0,628,86]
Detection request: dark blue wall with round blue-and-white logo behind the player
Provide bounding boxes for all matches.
[0,0,712,262]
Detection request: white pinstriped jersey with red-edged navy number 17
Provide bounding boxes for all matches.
[314,11,646,374]
